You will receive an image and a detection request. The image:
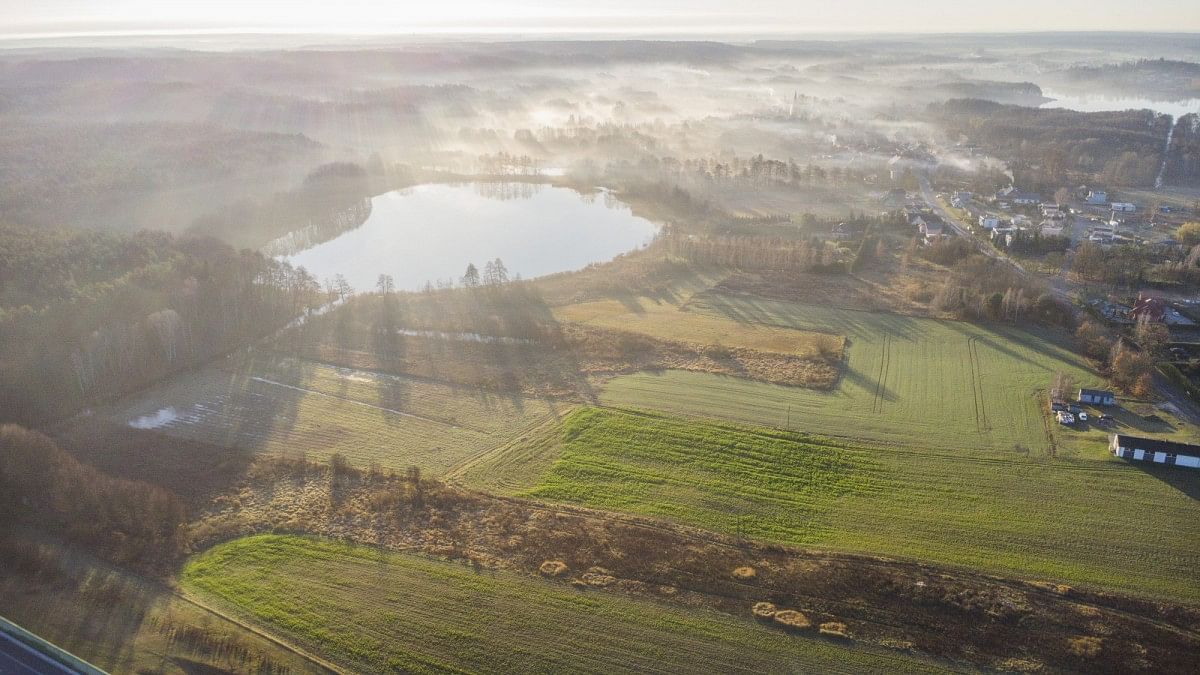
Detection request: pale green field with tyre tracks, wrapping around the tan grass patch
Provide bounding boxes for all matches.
[601,293,1194,453]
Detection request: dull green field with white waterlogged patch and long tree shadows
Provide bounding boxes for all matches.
[106,359,558,474]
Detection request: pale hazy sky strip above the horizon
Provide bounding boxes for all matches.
[0,0,1200,35]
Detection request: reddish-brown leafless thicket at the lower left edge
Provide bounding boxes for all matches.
[0,424,187,565]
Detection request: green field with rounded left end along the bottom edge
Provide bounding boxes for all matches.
[181,536,935,673]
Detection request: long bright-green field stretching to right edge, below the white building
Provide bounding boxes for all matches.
[501,408,1200,601]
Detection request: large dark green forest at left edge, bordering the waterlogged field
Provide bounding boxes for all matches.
[0,227,319,422]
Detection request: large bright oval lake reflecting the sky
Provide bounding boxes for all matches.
[282,183,659,291]
